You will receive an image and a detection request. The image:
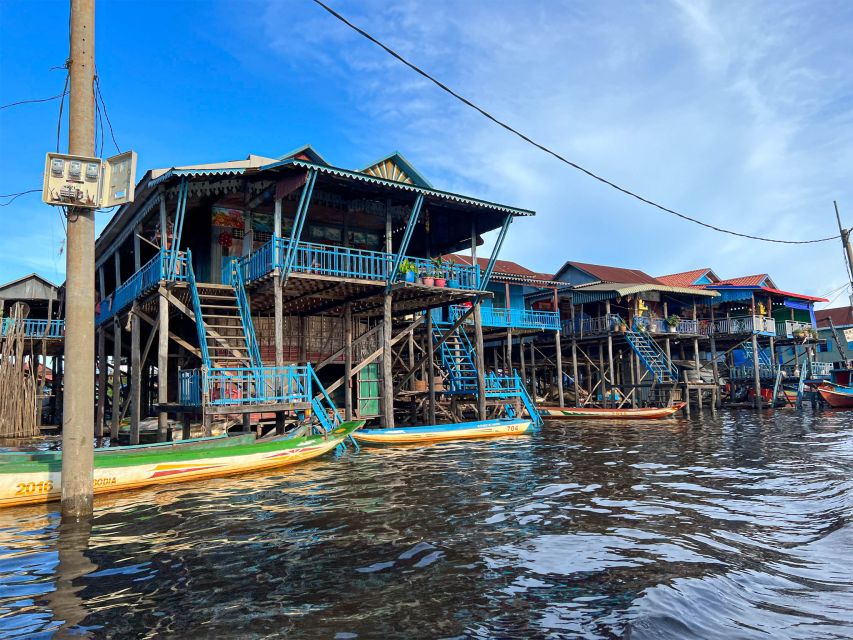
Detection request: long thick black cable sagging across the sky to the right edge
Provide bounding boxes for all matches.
[312,0,839,244]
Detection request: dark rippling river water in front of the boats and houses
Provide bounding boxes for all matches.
[0,410,853,640]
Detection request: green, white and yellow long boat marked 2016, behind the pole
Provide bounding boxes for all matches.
[0,420,364,507]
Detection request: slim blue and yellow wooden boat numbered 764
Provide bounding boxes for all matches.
[352,418,535,444]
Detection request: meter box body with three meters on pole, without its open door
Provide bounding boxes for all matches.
[41,153,102,209]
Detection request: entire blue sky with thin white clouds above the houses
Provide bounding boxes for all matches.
[0,0,853,303]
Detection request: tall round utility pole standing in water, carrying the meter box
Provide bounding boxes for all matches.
[62,0,95,521]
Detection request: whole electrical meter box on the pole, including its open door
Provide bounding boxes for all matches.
[42,151,136,209]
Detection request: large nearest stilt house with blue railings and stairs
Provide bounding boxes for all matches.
[91,146,535,443]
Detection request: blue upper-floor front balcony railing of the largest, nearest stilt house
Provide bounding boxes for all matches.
[240,237,480,290]
